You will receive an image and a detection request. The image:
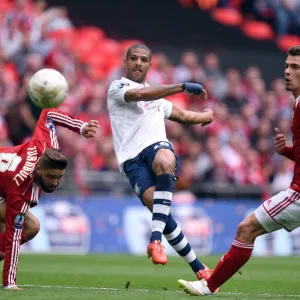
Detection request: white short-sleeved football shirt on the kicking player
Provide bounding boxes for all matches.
[107,77,172,173]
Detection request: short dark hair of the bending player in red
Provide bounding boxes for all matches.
[39,148,68,170]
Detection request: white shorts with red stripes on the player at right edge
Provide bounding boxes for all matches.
[254,188,300,232]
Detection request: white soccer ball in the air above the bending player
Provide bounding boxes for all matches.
[28,69,69,108]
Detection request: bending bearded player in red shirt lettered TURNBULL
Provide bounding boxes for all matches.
[0,109,99,289]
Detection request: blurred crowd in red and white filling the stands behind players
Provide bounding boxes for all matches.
[0,0,293,193]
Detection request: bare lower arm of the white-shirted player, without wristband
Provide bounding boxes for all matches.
[168,105,213,126]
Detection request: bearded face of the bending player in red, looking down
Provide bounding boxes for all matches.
[35,168,65,193]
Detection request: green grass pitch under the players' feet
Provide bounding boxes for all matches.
[0,254,300,300]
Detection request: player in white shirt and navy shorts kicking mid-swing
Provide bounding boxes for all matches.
[107,44,213,278]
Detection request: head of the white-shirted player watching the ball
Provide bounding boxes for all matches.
[124,49,152,83]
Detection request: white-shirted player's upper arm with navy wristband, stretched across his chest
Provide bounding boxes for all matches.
[124,82,207,102]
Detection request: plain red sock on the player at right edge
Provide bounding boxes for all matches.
[207,239,254,292]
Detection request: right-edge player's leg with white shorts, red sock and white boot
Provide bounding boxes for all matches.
[179,189,300,295]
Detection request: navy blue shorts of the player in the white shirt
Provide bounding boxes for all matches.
[123,142,176,202]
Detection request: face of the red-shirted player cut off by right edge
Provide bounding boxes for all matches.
[284,55,300,96]
